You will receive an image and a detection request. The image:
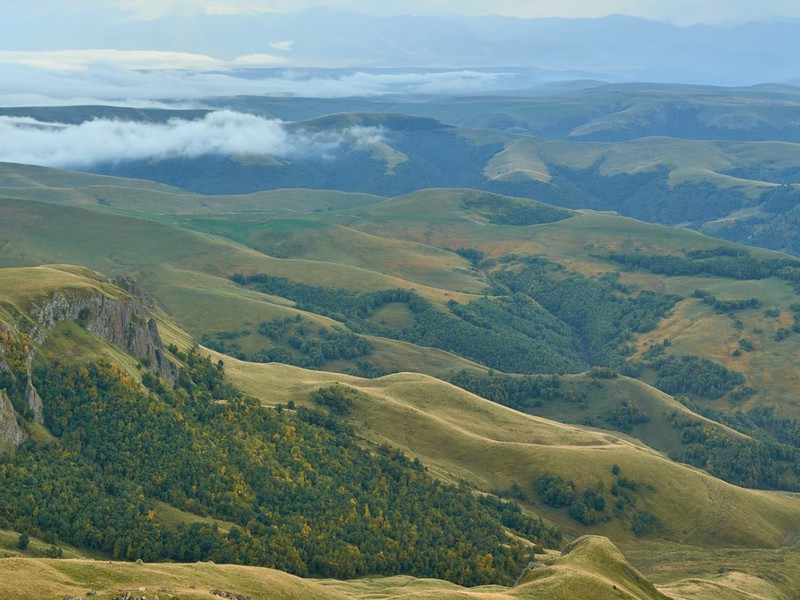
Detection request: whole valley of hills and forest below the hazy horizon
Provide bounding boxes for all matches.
[0,65,800,600]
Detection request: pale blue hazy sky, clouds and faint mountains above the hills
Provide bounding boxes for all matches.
[0,0,800,106]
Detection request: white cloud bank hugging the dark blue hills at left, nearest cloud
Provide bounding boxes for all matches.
[0,110,383,168]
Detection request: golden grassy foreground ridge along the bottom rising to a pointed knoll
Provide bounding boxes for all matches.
[0,537,666,600]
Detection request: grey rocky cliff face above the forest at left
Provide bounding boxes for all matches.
[0,282,178,452]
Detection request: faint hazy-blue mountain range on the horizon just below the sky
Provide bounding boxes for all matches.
[9,9,800,85]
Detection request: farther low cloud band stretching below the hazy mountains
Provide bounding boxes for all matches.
[0,58,524,106]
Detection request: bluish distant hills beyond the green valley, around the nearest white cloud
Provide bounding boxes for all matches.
[6,92,800,254]
